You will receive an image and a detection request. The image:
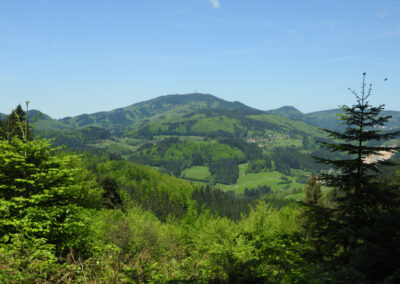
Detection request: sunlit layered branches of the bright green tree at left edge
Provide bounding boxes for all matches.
[0,137,101,260]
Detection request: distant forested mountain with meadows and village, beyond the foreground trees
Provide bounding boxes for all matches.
[22,93,400,201]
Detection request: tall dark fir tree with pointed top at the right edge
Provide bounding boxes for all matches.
[311,73,400,282]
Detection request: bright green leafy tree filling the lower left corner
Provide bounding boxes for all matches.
[0,137,102,282]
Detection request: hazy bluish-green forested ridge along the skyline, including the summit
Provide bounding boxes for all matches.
[0,93,400,135]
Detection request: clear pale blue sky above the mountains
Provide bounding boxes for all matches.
[0,0,400,118]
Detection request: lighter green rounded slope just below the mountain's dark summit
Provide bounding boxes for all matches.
[126,109,321,138]
